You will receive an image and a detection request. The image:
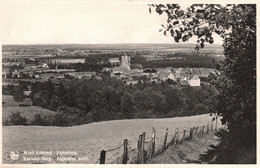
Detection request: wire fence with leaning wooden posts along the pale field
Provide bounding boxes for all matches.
[95,117,217,164]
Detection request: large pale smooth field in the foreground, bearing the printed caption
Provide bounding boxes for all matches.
[2,114,221,164]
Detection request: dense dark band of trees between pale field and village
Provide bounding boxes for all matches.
[6,77,217,126]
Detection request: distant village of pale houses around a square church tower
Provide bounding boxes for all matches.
[2,53,215,87]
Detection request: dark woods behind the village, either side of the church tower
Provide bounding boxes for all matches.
[63,53,218,72]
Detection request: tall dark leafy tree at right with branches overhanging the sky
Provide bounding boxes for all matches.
[149,4,256,163]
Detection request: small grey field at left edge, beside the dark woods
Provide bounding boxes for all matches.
[2,95,55,121]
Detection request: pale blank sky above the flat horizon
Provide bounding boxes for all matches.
[0,0,222,44]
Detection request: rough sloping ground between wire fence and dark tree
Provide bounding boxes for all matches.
[147,132,218,164]
